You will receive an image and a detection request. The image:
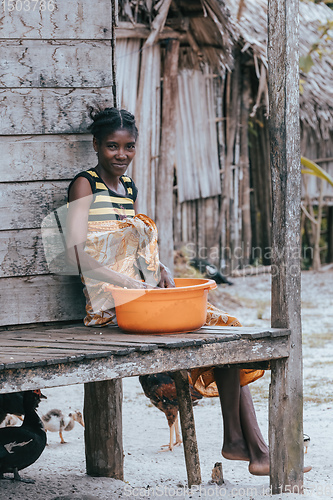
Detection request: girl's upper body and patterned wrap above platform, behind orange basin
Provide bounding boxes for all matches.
[66,108,175,326]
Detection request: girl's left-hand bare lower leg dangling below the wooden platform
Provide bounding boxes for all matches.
[214,368,250,461]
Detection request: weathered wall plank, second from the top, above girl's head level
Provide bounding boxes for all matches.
[0,40,112,88]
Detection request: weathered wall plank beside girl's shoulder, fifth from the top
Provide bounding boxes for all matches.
[0,181,69,230]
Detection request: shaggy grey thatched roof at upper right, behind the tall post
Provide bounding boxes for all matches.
[224,0,333,140]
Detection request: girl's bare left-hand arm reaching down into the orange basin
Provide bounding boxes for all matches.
[66,177,152,288]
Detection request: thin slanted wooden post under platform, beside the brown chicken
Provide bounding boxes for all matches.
[172,370,201,488]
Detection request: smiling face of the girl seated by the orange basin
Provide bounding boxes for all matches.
[93,129,135,177]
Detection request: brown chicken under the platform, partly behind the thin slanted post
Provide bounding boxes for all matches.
[139,372,202,451]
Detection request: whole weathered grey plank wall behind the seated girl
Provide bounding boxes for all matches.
[0,0,112,325]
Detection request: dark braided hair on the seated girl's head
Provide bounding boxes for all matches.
[88,107,139,142]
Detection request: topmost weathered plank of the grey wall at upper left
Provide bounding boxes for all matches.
[0,0,111,40]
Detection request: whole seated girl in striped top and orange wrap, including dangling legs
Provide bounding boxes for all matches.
[67,108,304,475]
